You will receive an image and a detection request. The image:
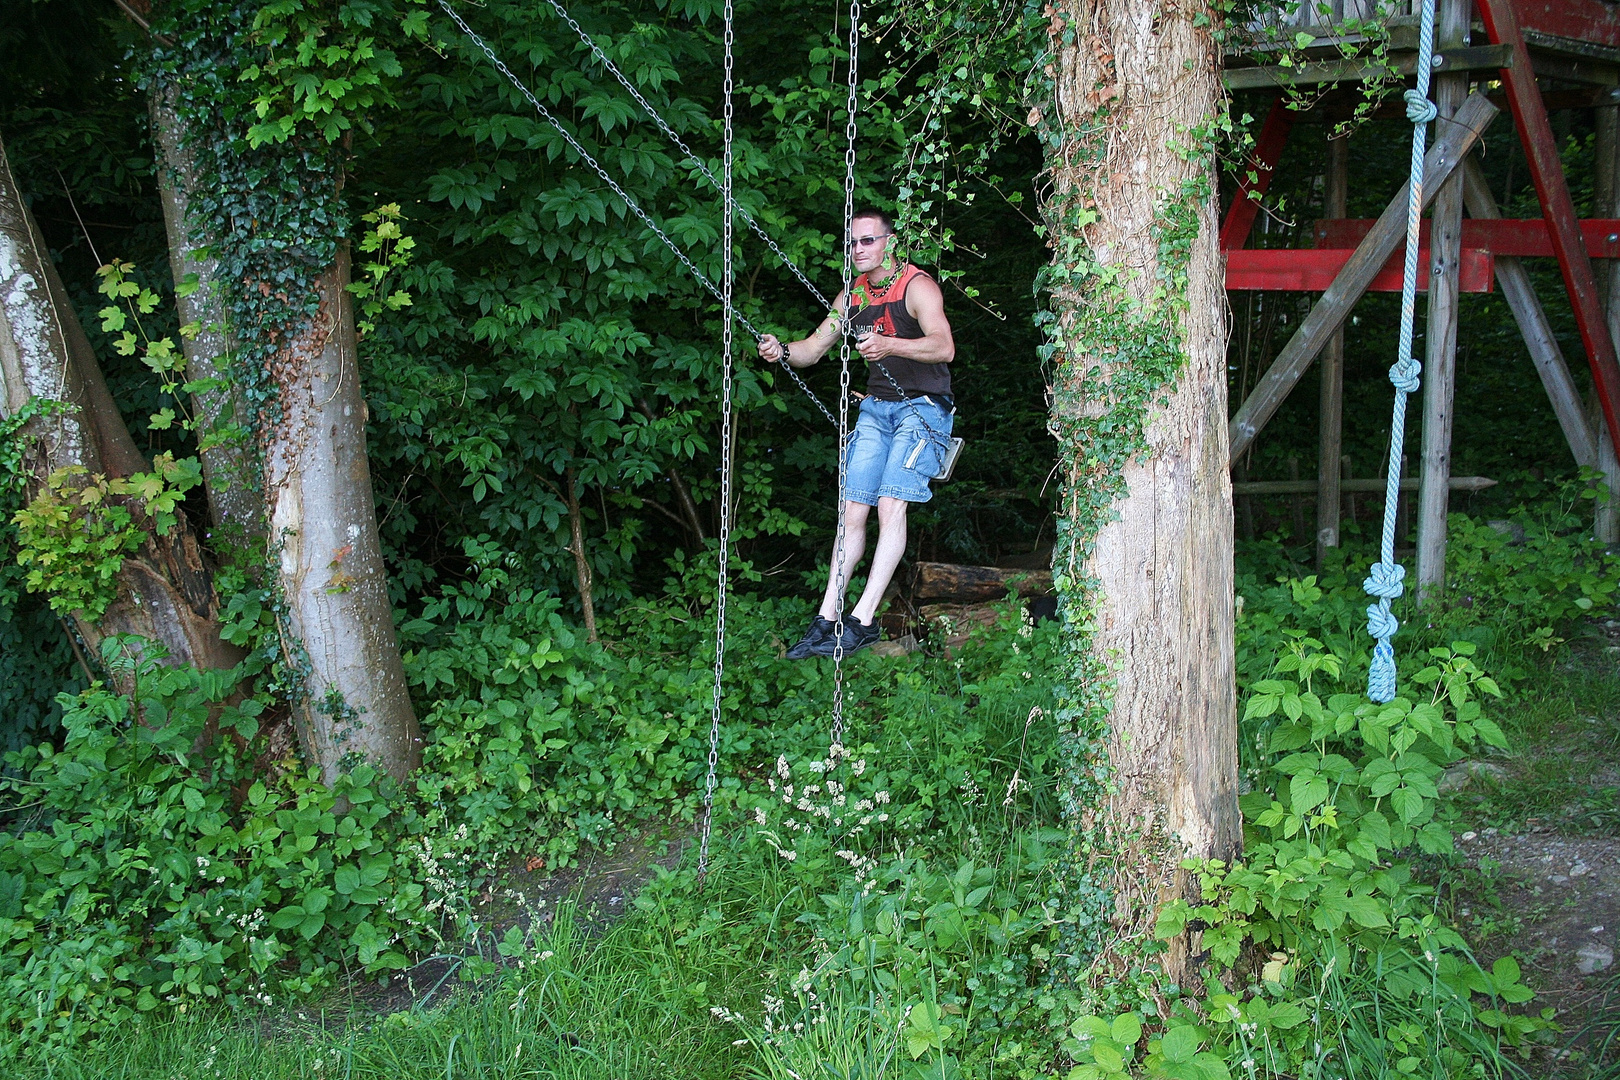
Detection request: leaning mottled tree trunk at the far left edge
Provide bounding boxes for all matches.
[0,146,241,667]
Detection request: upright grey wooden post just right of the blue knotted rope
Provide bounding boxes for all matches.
[1418,0,1473,602]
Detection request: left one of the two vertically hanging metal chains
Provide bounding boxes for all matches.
[698,0,735,886]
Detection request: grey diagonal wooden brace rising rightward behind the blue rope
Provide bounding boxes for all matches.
[1228,92,1497,460]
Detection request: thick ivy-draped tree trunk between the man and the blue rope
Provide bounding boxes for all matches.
[1030,0,1243,981]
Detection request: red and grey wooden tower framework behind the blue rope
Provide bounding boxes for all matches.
[1220,0,1620,588]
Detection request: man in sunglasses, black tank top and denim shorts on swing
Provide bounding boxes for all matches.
[760,209,956,661]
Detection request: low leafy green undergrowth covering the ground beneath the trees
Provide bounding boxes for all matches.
[0,501,1614,1080]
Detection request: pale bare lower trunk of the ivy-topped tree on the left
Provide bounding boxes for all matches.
[262,249,421,784]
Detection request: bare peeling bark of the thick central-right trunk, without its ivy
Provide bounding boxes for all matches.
[1047,0,1243,983]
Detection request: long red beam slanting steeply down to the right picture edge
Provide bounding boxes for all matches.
[1477,0,1620,459]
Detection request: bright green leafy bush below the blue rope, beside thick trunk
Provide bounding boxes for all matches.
[1157,635,1549,1075]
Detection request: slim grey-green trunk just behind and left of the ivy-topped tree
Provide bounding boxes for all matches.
[151,84,264,541]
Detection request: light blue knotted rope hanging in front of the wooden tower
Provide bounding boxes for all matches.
[1361,0,1439,703]
